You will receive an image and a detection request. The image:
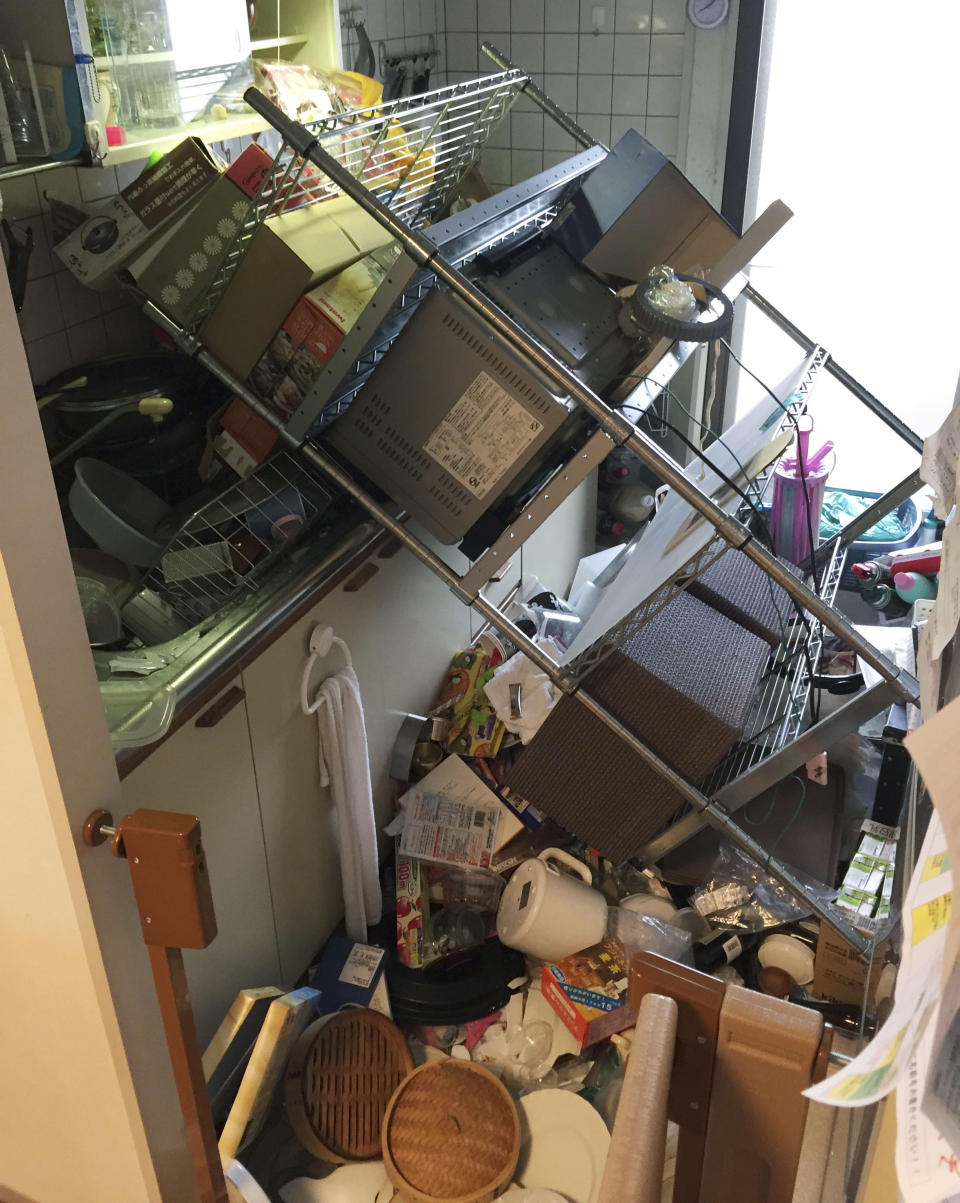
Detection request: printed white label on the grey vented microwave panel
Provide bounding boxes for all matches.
[423,372,544,498]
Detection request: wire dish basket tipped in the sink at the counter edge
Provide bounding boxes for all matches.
[144,452,332,624]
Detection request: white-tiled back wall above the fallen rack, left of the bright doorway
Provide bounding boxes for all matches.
[446,0,689,188]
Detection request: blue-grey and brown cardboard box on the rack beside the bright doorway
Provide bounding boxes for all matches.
[551,130,739,282]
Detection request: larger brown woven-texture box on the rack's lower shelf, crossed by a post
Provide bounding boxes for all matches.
[506,593,769,864]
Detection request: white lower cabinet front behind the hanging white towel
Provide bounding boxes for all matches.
[243,550,469,979]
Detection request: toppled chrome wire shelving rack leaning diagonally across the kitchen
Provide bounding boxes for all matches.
[135,46,920,954]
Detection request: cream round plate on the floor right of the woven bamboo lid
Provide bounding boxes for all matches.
[515,1090,610,1203]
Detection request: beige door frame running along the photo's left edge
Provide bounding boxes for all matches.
[0,278,196,1203]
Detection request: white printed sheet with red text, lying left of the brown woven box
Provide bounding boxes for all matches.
[399,793,500,869]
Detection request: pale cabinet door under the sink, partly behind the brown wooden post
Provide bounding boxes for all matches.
[122,678,284,1048]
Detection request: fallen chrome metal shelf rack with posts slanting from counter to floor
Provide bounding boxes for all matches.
[135,45,923,955]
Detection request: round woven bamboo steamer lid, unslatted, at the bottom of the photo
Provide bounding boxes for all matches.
[383,1060,520,1203]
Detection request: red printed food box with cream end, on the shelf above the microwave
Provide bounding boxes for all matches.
[250,243,399,420]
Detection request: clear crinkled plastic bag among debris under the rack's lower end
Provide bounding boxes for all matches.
[691,840,837,931]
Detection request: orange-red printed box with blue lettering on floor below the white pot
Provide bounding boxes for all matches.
[541,937,636,1048]
